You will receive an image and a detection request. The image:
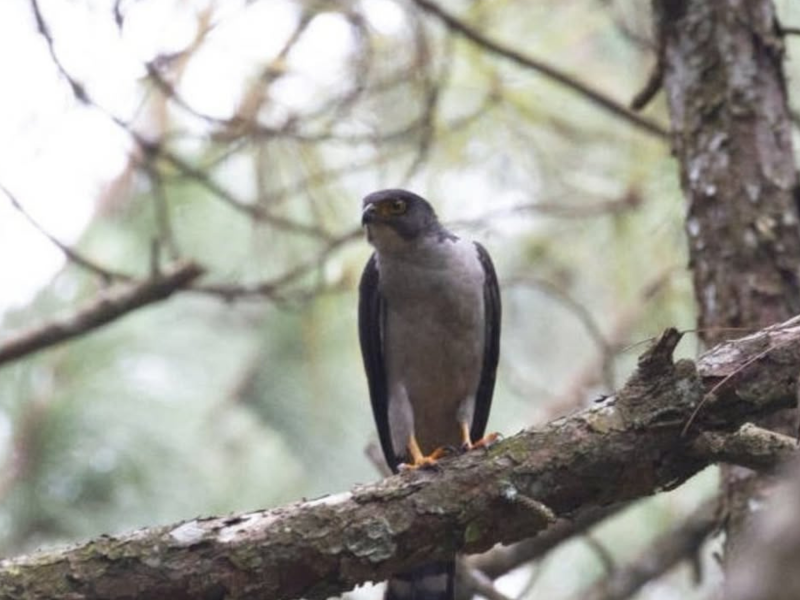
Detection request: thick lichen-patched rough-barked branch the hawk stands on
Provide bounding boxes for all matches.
[0,318,800,600]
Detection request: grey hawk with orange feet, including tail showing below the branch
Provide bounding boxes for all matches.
[358,189,501,600]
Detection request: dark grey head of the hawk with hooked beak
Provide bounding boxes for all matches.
[361,189,442,251]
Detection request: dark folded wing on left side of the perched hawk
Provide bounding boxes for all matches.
[358,254,399,473]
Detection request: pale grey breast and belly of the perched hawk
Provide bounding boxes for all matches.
[378,240,485,451]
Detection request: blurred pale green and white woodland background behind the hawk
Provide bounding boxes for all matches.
[0,0,800,598]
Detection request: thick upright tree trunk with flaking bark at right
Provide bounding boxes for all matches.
[654,0,800,552]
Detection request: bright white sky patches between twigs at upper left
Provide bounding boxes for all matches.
[0,0,401,315]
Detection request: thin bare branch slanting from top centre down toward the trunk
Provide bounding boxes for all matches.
[414,0,668,139]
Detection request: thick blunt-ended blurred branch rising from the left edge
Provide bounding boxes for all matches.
[0,262,203,366]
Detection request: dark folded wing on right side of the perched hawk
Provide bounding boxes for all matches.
[470,242,502,441]
